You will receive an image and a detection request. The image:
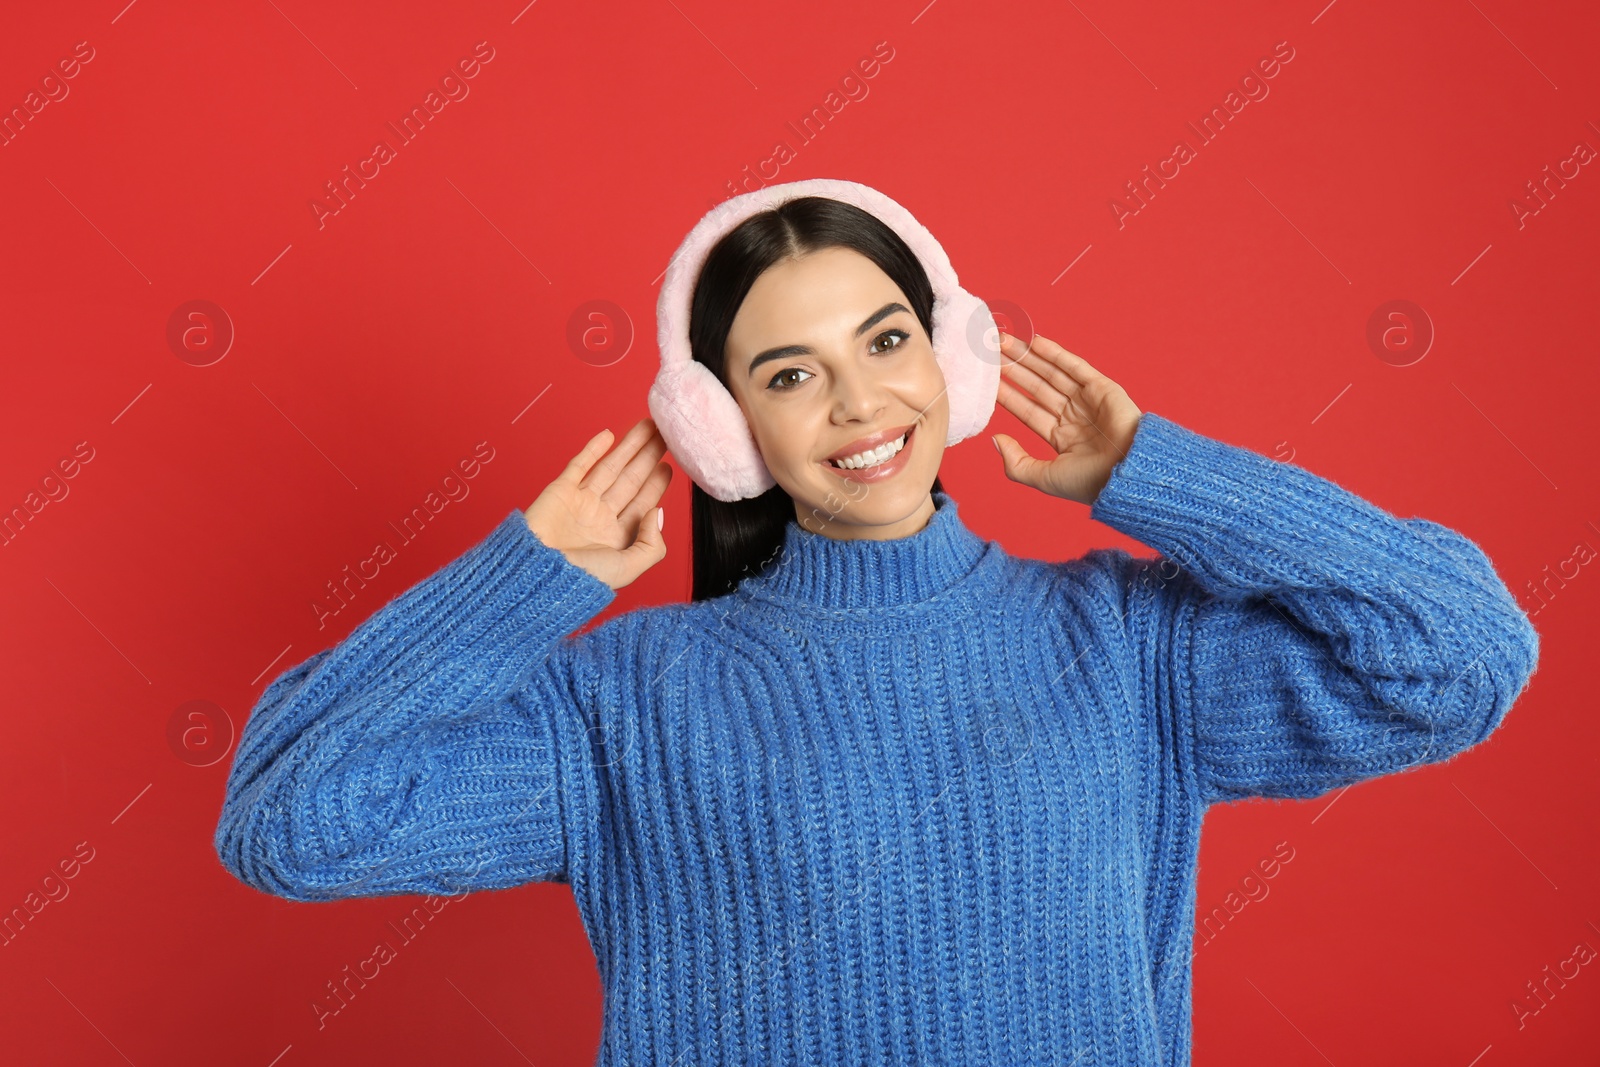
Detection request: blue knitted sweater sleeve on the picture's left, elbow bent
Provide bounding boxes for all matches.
[214,510,616,901]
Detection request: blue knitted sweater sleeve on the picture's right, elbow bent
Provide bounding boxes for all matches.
[1090,413,1539,803]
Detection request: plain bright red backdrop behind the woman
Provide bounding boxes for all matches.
[0,0,1600,1067]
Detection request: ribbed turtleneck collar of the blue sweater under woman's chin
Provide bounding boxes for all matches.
[739,493,987,611]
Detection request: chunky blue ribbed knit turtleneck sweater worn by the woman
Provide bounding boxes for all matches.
[216,413,1539,1067]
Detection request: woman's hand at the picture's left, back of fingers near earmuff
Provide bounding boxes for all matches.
[525,418,672,589]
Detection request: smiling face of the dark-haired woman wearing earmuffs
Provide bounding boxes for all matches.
[726,248,950,539]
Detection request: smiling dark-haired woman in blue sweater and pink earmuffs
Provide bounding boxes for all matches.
[216,181,1539,1065]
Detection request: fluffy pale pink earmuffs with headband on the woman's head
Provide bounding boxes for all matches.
[648,178,1000,502]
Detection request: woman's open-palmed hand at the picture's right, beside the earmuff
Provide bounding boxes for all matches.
[994,331,1142,506]
